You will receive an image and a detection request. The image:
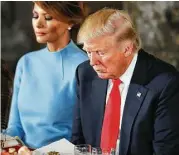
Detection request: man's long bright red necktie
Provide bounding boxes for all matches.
[101,79,121,151]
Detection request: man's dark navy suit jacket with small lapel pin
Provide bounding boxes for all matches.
[72,50,179,155]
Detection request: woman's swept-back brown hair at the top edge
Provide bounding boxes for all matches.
[34,1,88,25]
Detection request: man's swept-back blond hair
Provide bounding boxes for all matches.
[77,8,141,49]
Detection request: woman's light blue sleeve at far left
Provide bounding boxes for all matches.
[7,58,24,139]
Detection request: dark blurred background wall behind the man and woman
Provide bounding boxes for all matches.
[1,1,179,73]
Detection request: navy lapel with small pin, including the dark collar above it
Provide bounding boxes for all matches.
[119,50,151,155]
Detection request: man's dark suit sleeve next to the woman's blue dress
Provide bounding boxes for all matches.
[71,66,85,145]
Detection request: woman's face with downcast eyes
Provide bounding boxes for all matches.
[32,4,69,43]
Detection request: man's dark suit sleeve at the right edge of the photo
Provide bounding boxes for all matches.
[153,72,179,155]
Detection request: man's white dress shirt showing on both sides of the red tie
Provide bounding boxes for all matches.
[106,53,138,152]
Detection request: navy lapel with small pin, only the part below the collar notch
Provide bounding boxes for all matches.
[119,84,147,155]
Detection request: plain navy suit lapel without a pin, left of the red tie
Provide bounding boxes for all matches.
[91,76,108,146]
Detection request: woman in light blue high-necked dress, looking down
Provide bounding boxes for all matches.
[7,1,88,149]
